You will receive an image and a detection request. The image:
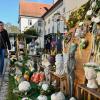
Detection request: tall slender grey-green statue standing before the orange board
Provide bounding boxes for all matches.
[67,43,77,97]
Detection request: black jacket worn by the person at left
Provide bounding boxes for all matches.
[0,29,11,50]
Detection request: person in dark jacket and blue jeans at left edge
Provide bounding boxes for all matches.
[0,21,11,75]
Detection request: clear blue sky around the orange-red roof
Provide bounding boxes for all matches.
[0,0,53,25]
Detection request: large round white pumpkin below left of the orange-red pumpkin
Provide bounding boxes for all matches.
[18,81,31,92]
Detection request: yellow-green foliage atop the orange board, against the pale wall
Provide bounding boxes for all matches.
[68,1,90,28]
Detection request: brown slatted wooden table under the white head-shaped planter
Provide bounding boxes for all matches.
[77,85,100,100]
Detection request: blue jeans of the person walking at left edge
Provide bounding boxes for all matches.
[0,49,5,74]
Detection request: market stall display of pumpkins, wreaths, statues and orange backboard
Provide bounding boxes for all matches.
[8,0,100,100]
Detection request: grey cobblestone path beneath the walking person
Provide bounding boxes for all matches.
[0,59,9,100]
